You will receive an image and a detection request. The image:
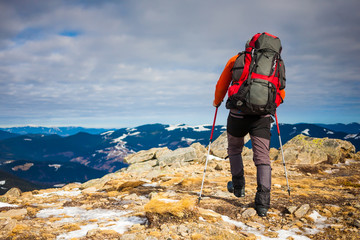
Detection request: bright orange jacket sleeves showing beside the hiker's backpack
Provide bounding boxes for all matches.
[213,54,285,106]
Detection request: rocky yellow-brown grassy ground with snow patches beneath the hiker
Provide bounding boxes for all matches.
[0,134,360,240]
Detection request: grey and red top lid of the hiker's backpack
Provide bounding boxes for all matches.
[246,32,282,54]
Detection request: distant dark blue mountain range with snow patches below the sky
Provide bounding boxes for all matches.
[0,123,360,194]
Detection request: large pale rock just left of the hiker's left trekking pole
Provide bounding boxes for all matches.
[158,147,197,166]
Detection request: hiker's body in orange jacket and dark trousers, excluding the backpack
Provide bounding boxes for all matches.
[213,33,285,216]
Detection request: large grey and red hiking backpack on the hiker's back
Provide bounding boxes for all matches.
[226,32,286,115]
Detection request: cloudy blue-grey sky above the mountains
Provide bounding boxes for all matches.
[0,0,360,128]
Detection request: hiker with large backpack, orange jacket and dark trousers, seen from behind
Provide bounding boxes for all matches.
[213,33,286,216]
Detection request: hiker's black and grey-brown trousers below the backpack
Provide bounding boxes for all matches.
[227,114,272,208]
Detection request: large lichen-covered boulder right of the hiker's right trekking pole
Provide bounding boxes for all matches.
[274,134,355,164]
